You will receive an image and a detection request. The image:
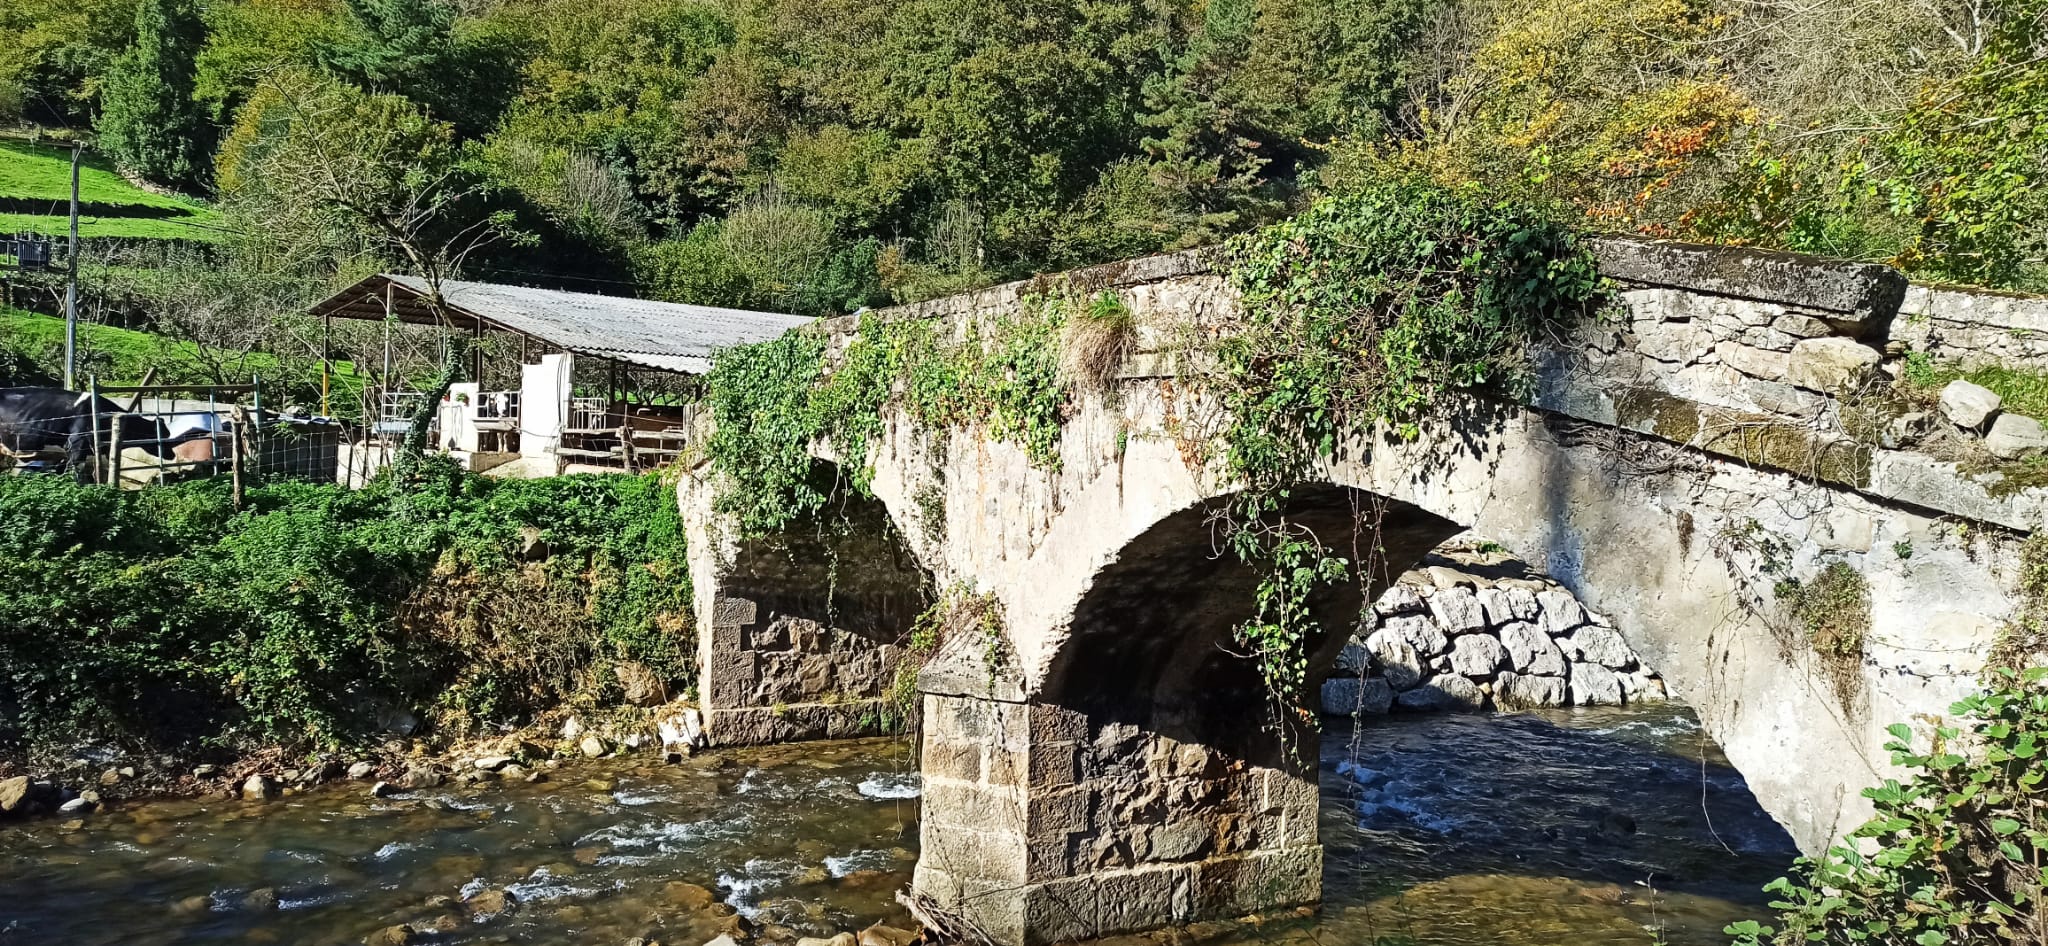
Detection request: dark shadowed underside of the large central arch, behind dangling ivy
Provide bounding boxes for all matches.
[1038,483,1464,768]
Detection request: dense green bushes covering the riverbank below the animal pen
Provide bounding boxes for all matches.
[0,465,694,754]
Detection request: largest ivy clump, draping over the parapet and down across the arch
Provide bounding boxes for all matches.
[1204,180,1608,721]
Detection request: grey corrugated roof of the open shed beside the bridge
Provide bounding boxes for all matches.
[383,274,811,375]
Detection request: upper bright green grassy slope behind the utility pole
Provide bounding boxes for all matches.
[0,139,219,240]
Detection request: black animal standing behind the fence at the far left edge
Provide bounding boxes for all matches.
[0,387,207,483]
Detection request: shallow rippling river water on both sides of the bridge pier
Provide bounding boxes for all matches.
[0,706,1794,946]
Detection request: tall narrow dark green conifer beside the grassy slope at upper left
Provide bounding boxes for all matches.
[98,0,207,184]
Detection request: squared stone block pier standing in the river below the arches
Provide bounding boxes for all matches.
[915,694,1323,946]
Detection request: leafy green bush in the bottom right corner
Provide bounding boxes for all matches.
[1729,668,2048,946]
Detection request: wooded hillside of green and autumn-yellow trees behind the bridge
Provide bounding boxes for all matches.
[0,0,2048,364]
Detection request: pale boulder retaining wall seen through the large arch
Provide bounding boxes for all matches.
[1323,547,1665,717]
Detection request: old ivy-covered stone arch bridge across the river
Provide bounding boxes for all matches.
[680,240,2048,946]
